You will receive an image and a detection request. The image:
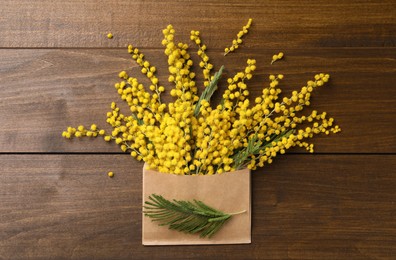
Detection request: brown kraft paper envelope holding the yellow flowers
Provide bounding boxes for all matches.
[142,167,251,245]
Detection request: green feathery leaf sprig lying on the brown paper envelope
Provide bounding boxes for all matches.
[143,194,245,238]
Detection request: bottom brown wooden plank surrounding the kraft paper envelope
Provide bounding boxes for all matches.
[0,155,396,259]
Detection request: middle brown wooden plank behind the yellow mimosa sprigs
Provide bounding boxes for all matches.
[0,48,396,153]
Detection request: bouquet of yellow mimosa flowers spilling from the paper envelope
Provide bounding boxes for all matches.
[62,20,340,174]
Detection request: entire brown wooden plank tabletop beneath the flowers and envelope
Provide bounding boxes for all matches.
[0,0,396,259]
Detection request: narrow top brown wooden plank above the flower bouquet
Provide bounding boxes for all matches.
[0,0,396,49]
